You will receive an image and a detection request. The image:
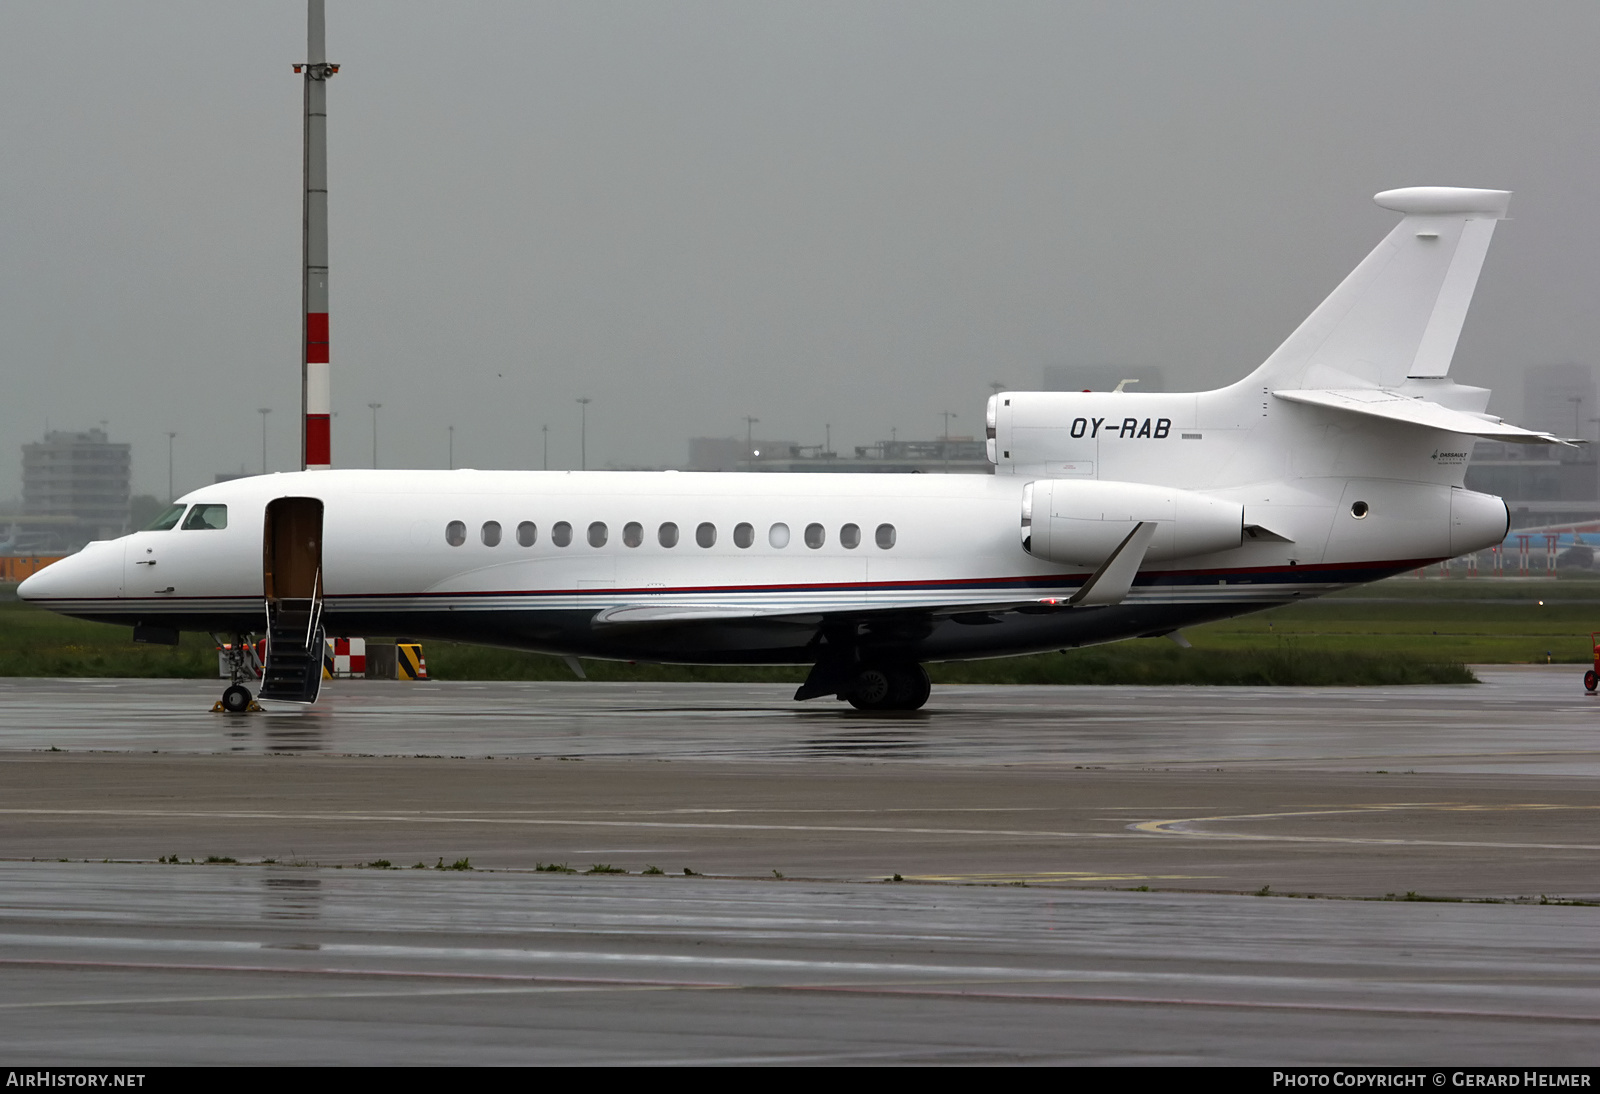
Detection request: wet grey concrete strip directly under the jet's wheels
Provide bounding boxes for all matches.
[0,667,1600,776]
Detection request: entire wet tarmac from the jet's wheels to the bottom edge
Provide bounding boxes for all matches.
[0,669,1600,1064]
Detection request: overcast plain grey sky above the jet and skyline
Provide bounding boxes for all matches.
[0,0,1600,497]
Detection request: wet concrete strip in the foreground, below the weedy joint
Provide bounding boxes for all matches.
[0,864,1600,1067]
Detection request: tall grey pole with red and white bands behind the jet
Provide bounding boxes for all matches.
[294,0,339,470]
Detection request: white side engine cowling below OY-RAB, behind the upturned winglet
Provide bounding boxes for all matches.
[1022,478,1245,566]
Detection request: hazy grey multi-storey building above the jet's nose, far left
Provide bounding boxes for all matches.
[16,429,133,550]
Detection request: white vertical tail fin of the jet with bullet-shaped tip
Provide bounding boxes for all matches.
[1246,186,1510,389]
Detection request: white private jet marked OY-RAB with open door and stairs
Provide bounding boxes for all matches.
[19,187,1568,710]
